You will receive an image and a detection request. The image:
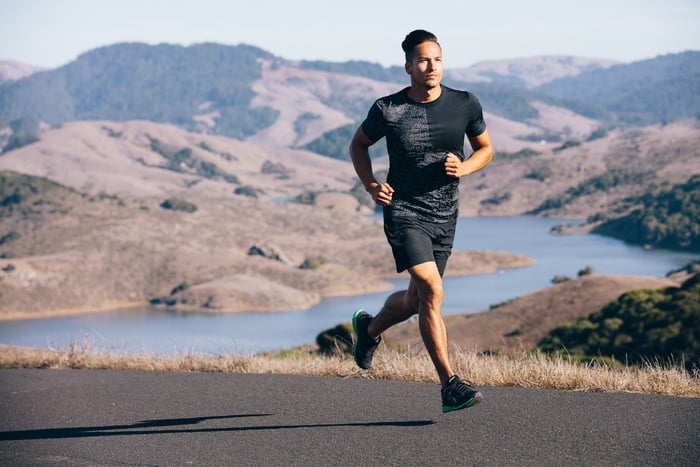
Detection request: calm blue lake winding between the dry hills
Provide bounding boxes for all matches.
[0,216,698,355]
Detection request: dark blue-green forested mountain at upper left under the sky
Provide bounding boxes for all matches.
[0,43,276,137]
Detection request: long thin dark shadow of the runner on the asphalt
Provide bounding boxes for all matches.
[0,413,435,441]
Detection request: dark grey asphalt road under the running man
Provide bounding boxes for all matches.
[0,370,700,466]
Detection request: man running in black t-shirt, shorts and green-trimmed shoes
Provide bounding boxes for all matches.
[350,30,493,412]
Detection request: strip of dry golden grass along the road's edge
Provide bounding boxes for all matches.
[0,344,700,397]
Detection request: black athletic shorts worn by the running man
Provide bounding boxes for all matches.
[384,216,457,276]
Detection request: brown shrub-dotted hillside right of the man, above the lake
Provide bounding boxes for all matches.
[460,122,700,219]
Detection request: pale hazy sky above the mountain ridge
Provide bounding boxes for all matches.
[0,0,700,68]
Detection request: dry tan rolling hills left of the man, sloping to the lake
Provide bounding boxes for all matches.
[0,121,528,319]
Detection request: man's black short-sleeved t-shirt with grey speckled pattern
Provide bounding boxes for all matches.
[362,86,486,223]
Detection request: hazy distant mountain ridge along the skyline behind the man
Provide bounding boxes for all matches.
[0,43,700,153]
